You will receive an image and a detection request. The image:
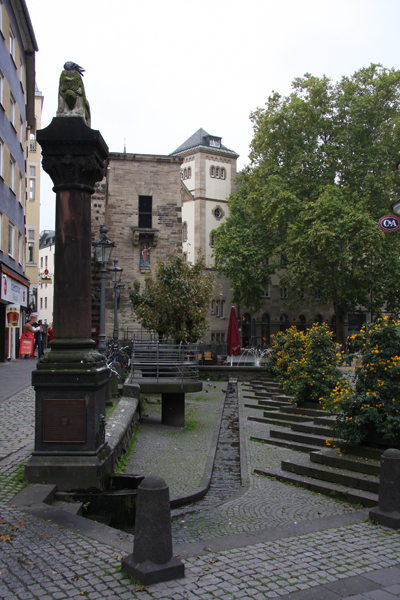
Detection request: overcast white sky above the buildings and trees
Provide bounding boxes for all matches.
[26,0,400,230]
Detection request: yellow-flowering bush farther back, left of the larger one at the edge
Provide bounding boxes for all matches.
[270,324,341,402]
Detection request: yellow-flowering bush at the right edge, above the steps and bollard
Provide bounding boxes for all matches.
[324,317,400,444]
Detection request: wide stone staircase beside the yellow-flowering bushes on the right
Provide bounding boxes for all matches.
[244,382,384,507]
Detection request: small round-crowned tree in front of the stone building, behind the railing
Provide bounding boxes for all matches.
[129,253,214,343]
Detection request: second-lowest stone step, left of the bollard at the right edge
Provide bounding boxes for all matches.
[281,456,379,495]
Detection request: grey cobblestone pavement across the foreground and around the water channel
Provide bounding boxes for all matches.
[0,366,400,600]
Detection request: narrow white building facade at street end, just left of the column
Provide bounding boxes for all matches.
[37,229,55,325]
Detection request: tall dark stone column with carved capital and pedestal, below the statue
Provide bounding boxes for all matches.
[25,116,112,491]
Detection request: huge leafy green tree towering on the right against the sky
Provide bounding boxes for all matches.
[215,65,400,343]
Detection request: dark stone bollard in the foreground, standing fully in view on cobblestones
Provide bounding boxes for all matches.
[121,475,185,585]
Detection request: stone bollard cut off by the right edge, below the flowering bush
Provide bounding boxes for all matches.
[369,448,400,529]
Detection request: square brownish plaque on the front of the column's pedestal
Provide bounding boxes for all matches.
[43,398,86,444]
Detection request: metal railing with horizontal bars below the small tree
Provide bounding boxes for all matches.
[130,340,199,382]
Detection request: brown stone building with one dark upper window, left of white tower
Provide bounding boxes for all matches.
[92,152,183,338]
